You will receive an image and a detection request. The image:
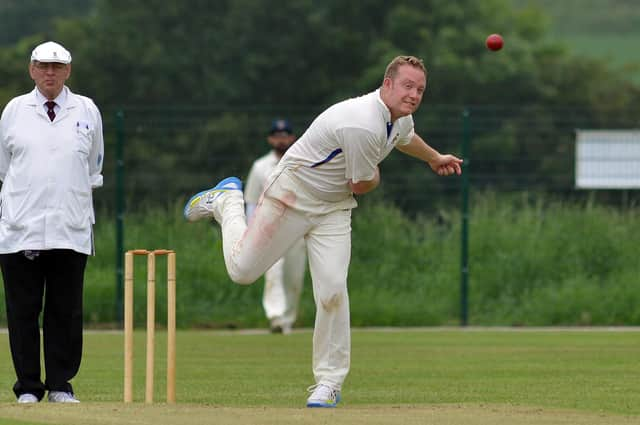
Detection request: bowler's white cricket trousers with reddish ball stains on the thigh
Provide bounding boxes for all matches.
[216,169,351,390]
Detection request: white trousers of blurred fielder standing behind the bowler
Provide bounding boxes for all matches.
[262,239,307,329]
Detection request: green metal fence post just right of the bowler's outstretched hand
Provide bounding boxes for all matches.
[460,108,471,326]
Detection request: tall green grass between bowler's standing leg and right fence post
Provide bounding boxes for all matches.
[349,199,459,326]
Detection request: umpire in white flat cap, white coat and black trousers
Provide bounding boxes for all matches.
[0,41,104,403]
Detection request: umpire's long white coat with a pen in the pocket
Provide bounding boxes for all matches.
[0,86,104,254]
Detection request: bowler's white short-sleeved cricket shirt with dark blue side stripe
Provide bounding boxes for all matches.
[278,90,415,202]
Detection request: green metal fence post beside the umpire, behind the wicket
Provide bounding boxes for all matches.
[115,110,125,323]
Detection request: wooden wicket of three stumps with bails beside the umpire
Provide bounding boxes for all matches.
[124,249,176,403]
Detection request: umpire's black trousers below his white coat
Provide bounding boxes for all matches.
[0,249,87,399]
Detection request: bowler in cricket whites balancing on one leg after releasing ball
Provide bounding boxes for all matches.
[184,56,462,407]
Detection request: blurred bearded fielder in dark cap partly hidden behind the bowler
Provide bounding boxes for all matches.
[244,119,307,334]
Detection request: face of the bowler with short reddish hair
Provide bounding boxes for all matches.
[383,65,427,119]
